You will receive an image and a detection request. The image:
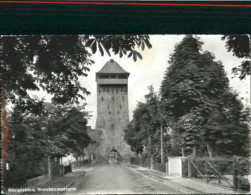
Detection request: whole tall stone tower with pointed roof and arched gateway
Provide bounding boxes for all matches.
[96,59,131,158]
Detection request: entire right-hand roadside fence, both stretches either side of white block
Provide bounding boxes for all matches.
[130,157,250,190]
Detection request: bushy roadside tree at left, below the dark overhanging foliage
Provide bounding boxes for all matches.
[8,104,92,179]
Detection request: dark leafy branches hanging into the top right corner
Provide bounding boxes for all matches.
[222,34,251,80]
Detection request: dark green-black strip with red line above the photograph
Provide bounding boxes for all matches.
[0,1,251,34]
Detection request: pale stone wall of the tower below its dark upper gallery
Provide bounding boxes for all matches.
[96,84,130,156]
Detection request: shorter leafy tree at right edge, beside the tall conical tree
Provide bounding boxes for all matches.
[204,92,250,157]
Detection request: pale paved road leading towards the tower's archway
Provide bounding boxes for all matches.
[70,164,196,194]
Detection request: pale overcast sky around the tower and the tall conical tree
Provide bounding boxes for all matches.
[77,35,250,128]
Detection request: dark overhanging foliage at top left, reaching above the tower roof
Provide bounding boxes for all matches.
[0,35,151,106]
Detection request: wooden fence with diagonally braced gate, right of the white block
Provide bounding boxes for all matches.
[187,158,250,190]
